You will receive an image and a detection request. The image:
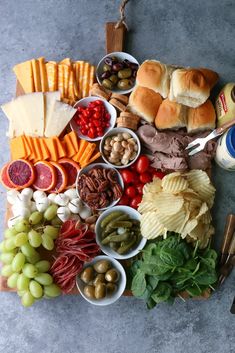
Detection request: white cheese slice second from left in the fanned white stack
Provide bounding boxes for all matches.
[17,92,45,136]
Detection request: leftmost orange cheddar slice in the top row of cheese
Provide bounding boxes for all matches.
[13,60,34,93]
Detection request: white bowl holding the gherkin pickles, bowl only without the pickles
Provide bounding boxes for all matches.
[95,206,147,260]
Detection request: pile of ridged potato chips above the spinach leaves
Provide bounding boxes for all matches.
[138,170,215,248]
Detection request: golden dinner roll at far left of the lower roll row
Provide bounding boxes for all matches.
[128,86,162,123]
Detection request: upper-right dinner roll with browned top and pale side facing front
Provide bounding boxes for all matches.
[169,69,210,108]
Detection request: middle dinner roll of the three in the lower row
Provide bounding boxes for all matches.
[155,99,187,130]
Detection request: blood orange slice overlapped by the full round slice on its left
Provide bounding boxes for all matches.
[33,161,56,191]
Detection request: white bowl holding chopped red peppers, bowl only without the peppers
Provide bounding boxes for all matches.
[70,96,117,141]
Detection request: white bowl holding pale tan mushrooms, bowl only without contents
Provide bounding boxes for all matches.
[100,127,141,169]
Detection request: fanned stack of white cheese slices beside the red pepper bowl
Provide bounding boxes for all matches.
[1,91,77,138]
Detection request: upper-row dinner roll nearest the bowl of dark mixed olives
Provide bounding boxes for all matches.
[136,60,173,98]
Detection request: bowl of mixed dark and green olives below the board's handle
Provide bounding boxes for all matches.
[96,52,139,94]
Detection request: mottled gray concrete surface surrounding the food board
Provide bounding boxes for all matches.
[0,0,235,353]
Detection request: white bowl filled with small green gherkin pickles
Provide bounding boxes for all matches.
[95,205,147,260]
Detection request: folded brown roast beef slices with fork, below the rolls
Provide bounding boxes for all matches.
[137,124,216,171]
